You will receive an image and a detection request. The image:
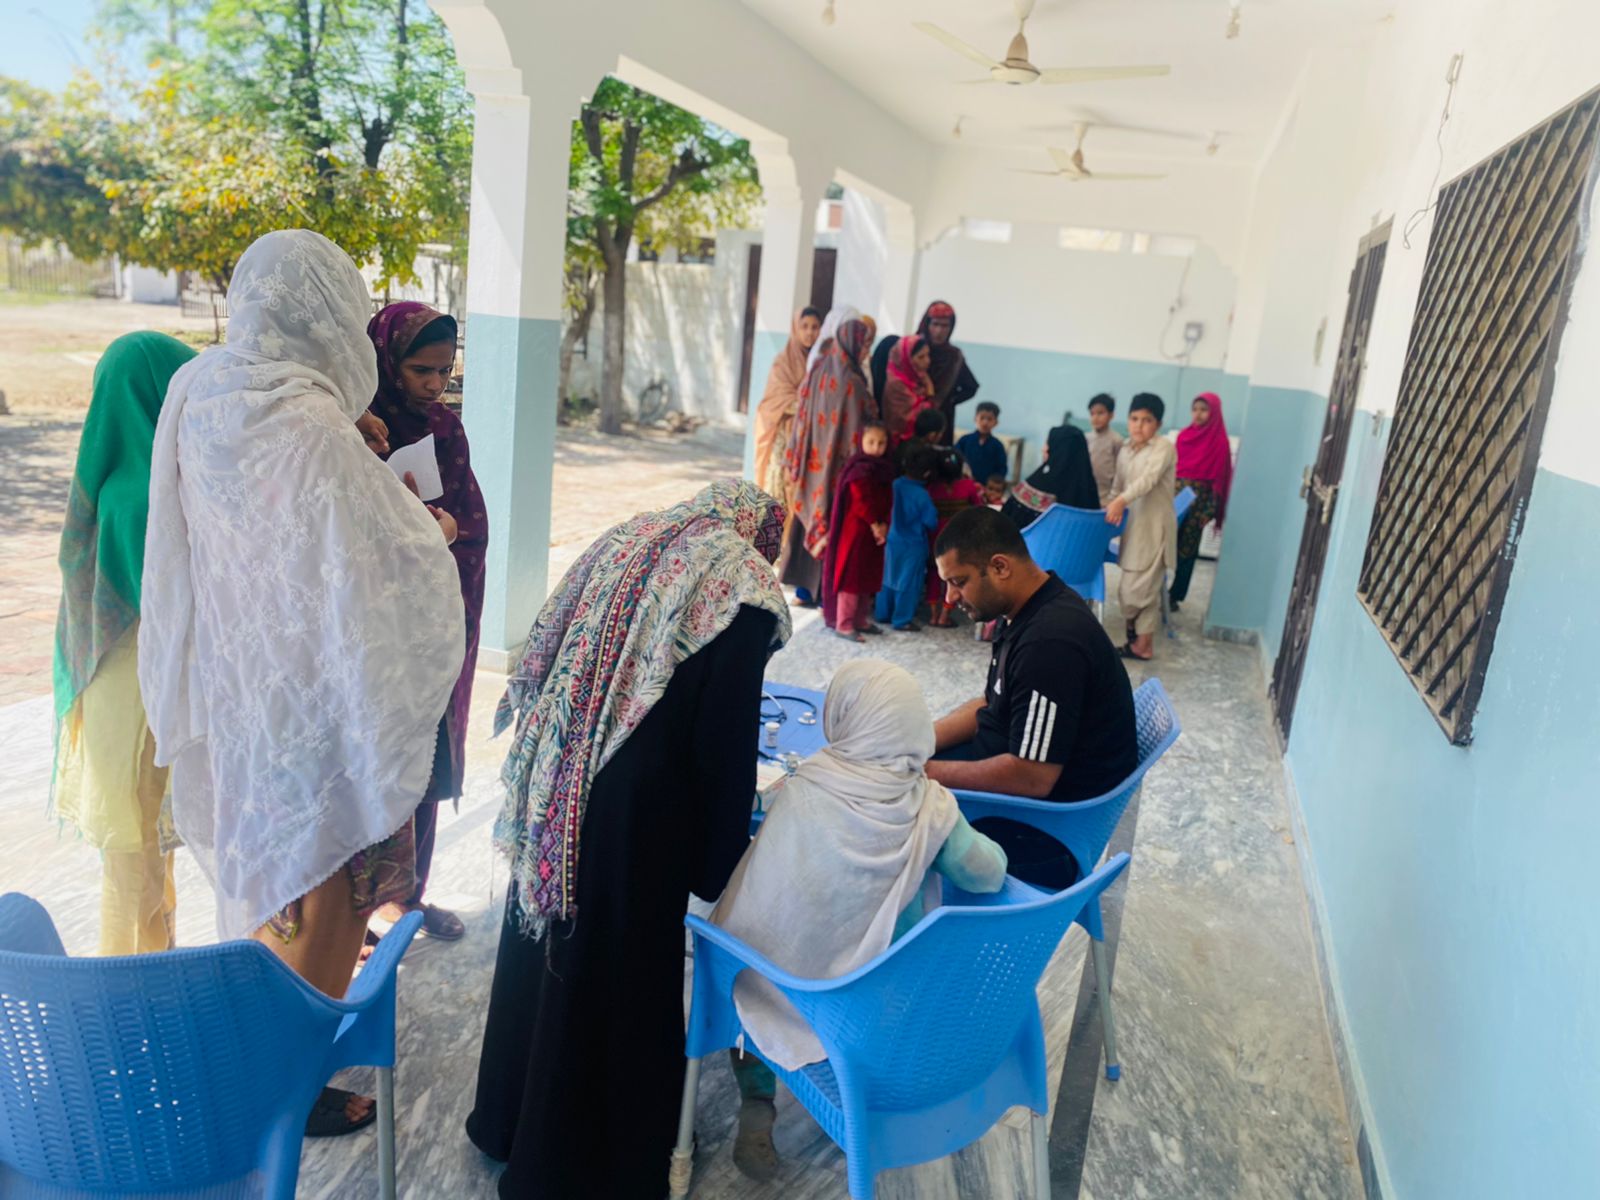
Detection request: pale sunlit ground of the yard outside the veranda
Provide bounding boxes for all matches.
[0,294,744,706]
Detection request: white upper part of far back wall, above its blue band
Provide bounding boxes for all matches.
[914,224,1235,366]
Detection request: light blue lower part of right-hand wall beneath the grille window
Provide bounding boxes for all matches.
[1288,418,1600,1197]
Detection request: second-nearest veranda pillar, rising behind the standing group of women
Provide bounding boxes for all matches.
[744,153,832,475]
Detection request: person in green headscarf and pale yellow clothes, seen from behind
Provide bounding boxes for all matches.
[54,331,195,954]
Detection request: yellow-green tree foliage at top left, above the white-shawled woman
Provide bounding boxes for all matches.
[0,0,472,285]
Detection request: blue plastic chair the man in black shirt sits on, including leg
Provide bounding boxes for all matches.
[955,678,1182,1080]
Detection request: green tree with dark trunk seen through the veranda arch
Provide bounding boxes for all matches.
[563,77,760,434]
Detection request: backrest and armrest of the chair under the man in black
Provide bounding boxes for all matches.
[955,678,1182,869]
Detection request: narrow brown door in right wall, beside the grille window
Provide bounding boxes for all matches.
[1270,222,1389,744]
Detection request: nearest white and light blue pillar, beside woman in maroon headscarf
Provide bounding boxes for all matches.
[462,70,579,670]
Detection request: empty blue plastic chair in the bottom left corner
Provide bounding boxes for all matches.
[0,893,422,1200]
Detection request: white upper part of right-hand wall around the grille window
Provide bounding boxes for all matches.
[1229,0,1600,483]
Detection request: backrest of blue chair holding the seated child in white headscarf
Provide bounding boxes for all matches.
[774,854,1128,1114]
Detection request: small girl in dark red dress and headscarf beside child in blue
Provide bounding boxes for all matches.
[822,421,894,642]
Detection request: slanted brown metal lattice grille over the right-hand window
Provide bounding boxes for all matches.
[1357,88,1600,746]
